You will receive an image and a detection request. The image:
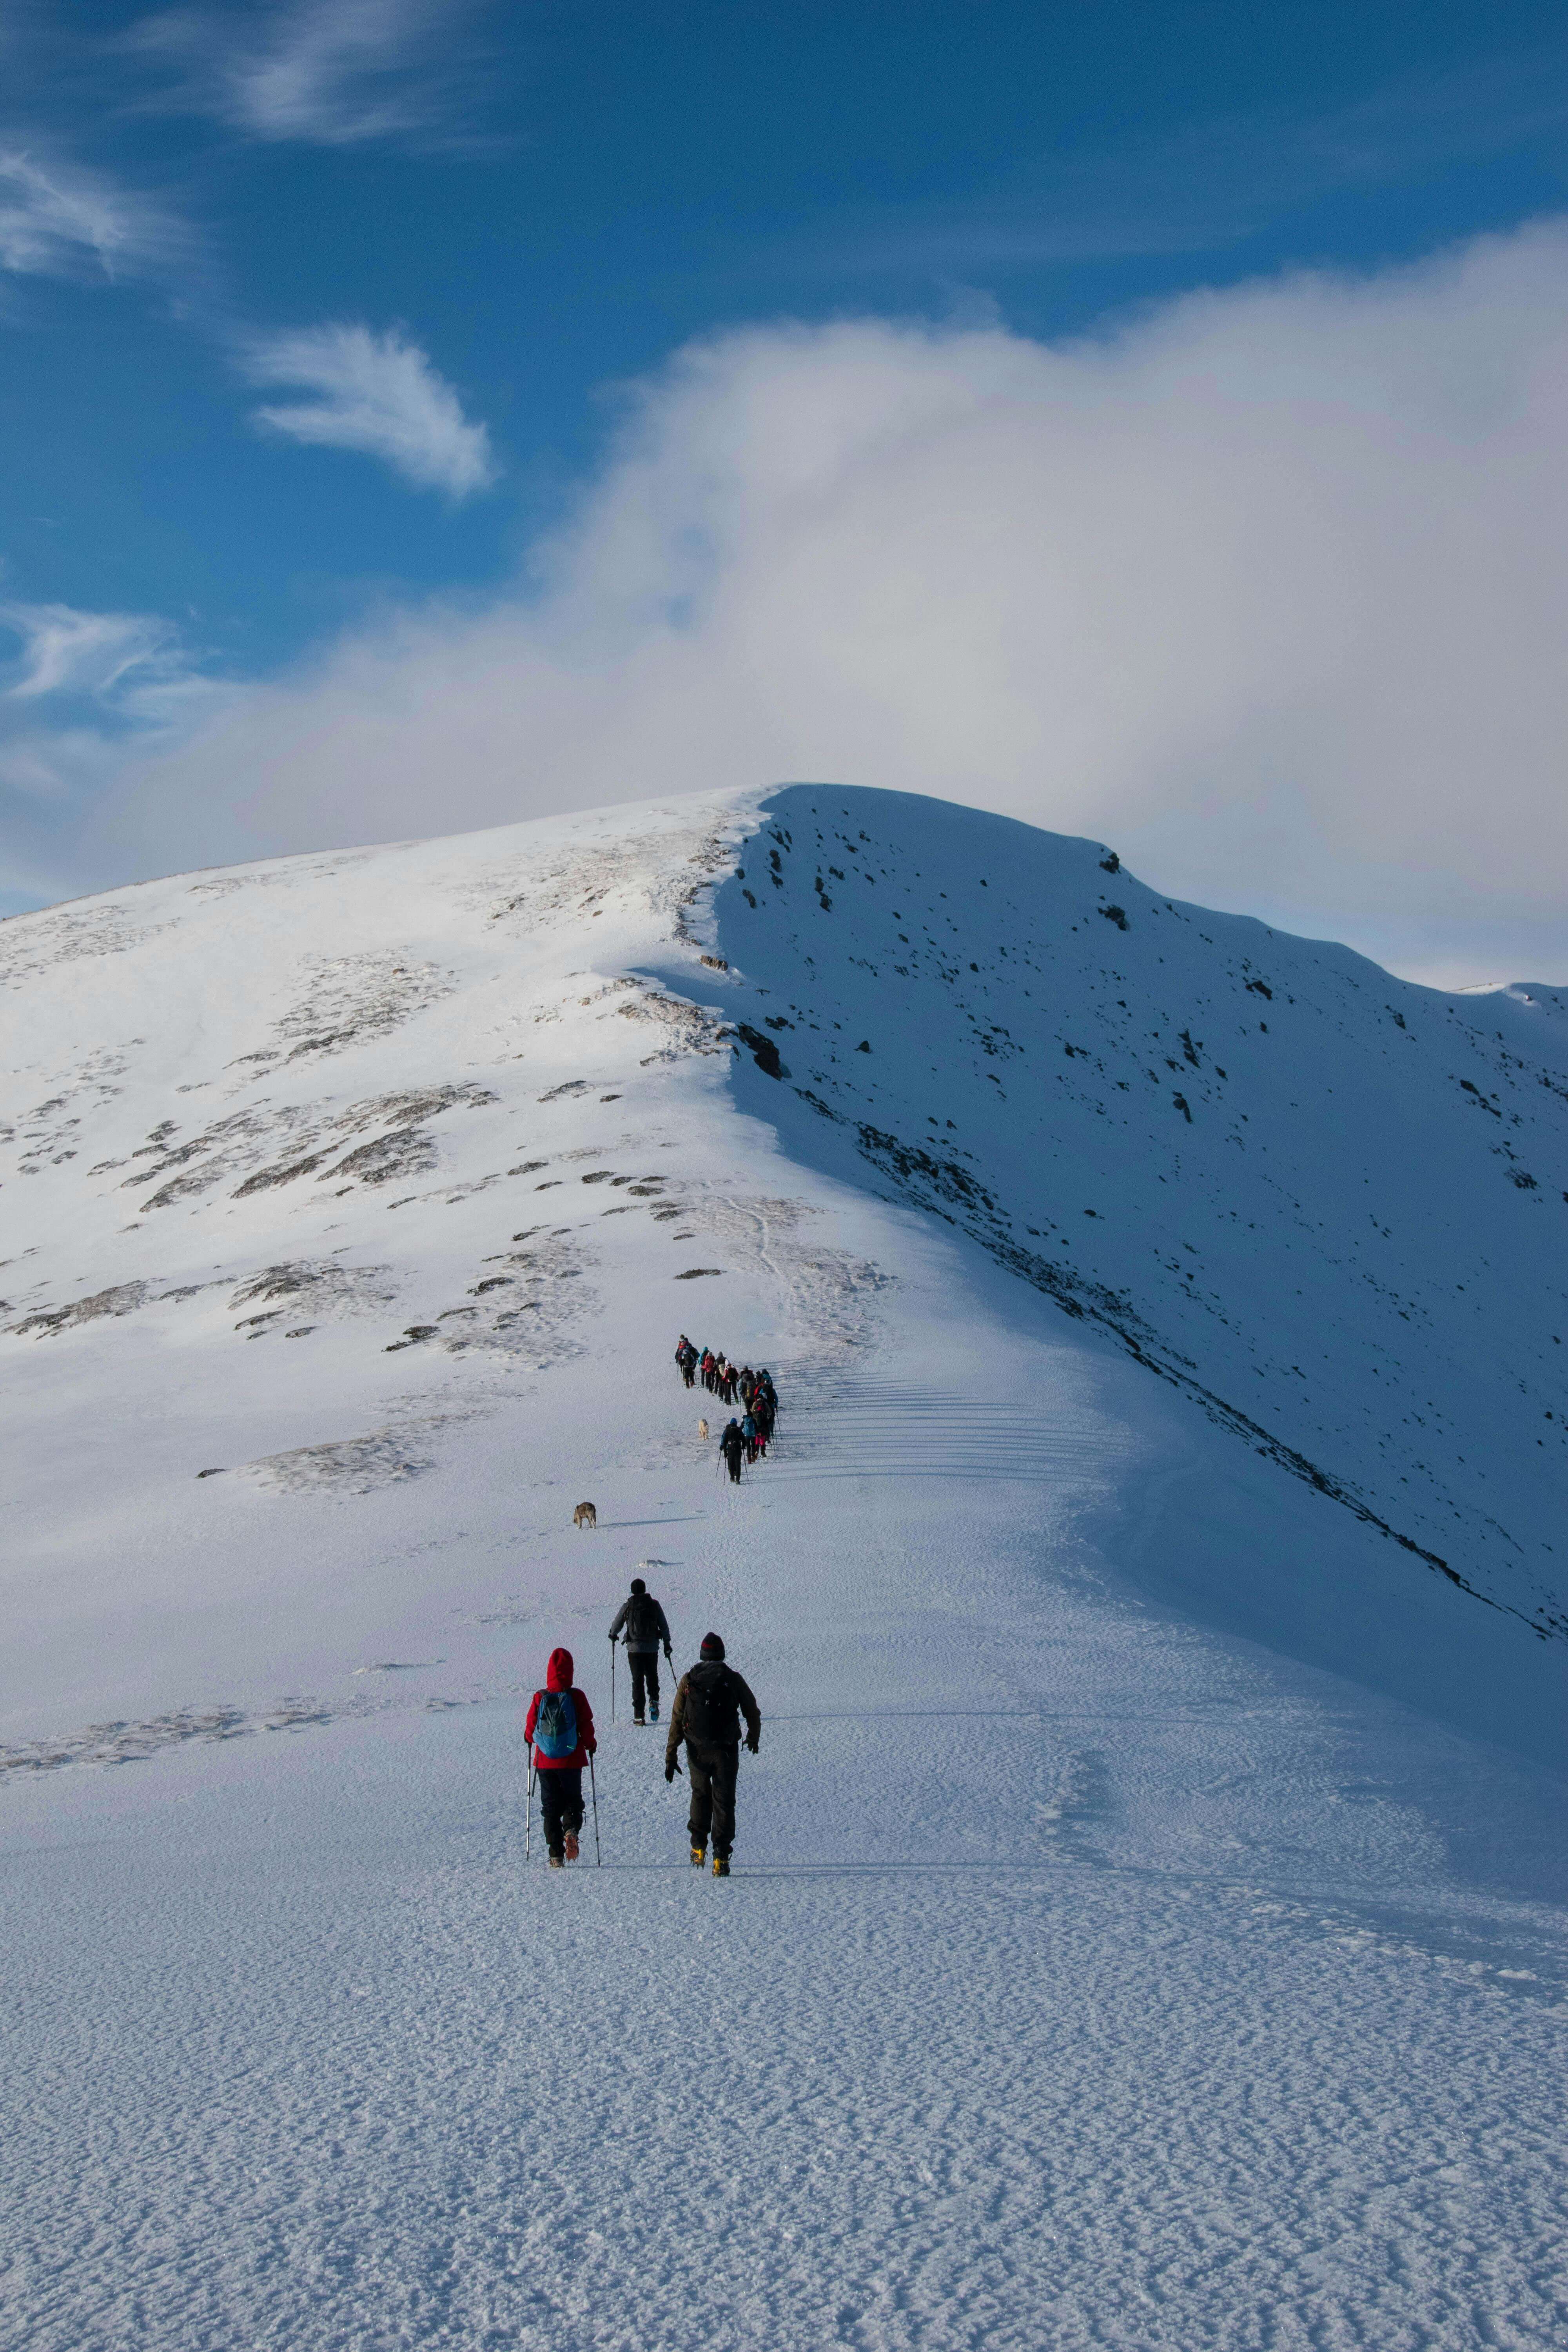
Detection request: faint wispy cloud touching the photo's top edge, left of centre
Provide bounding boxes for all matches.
[129,0,496,146]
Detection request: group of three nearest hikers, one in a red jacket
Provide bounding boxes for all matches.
[522,1576,762,1879]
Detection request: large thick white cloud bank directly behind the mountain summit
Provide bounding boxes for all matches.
[55,223,1568,976]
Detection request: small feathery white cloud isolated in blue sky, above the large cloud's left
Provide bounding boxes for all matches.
[245,325,496,499]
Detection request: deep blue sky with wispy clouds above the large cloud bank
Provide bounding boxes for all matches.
[0,0,1568,974]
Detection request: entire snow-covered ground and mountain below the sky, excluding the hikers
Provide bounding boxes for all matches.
[0,786,1568,2352]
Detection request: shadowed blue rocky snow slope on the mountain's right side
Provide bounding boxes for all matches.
[715,788,1568,1766]
